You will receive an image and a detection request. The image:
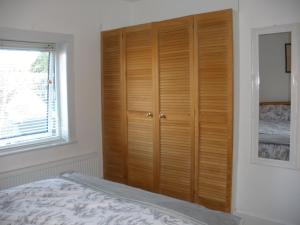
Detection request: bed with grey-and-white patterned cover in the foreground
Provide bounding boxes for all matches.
[0,173,241,225]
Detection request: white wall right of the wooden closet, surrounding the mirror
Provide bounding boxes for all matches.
[236,0,300,225]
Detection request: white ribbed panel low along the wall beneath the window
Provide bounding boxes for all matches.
[0,153,99,190]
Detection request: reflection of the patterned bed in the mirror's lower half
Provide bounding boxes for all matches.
[258,102,291,161]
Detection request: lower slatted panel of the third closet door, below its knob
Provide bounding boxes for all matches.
[160,119,193,200]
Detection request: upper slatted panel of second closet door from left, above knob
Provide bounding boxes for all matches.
[125,26,153,112]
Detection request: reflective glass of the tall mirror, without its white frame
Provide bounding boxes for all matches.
[258,32,291,161]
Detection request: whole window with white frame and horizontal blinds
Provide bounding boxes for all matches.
[0,28,74,154]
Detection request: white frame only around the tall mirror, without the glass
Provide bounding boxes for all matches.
[251,23,300,169]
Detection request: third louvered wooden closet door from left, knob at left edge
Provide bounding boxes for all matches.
[156,17,194,200]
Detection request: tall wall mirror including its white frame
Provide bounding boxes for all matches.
[252,25,299,167]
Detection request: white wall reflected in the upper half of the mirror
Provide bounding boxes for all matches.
[259,32,291,102]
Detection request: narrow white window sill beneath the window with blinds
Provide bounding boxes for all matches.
[0,140,77,157]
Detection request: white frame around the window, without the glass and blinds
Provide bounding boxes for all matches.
[0,27,76,155]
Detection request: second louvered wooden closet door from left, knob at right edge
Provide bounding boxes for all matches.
[124,25,154,191]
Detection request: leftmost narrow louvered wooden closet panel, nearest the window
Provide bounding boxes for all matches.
[102,31,126,183]
